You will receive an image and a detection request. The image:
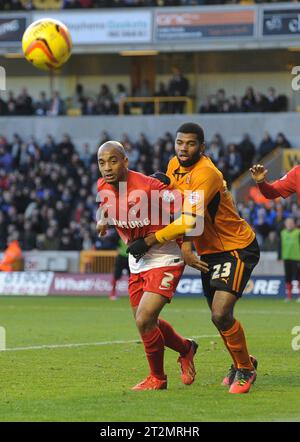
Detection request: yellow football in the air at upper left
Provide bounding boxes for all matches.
[22,18,72,71]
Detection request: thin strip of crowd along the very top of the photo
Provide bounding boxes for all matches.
[0,0,290,11]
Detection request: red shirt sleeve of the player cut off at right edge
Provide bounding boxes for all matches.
[258,165,300,202]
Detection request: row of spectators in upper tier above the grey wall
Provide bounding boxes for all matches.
[0,83,288,116]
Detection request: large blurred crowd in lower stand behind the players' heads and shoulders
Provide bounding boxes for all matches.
[0,128,294,250]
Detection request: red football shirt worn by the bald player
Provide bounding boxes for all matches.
[97,170,181,244]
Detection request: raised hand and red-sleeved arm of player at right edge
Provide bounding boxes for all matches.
[250,164,300,202]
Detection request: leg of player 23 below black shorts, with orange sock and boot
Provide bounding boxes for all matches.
[209,290,257,393]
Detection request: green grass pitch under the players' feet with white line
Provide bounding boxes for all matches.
[0,297,300,422]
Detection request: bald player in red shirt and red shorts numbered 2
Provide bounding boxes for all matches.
[97,141,204,390]
